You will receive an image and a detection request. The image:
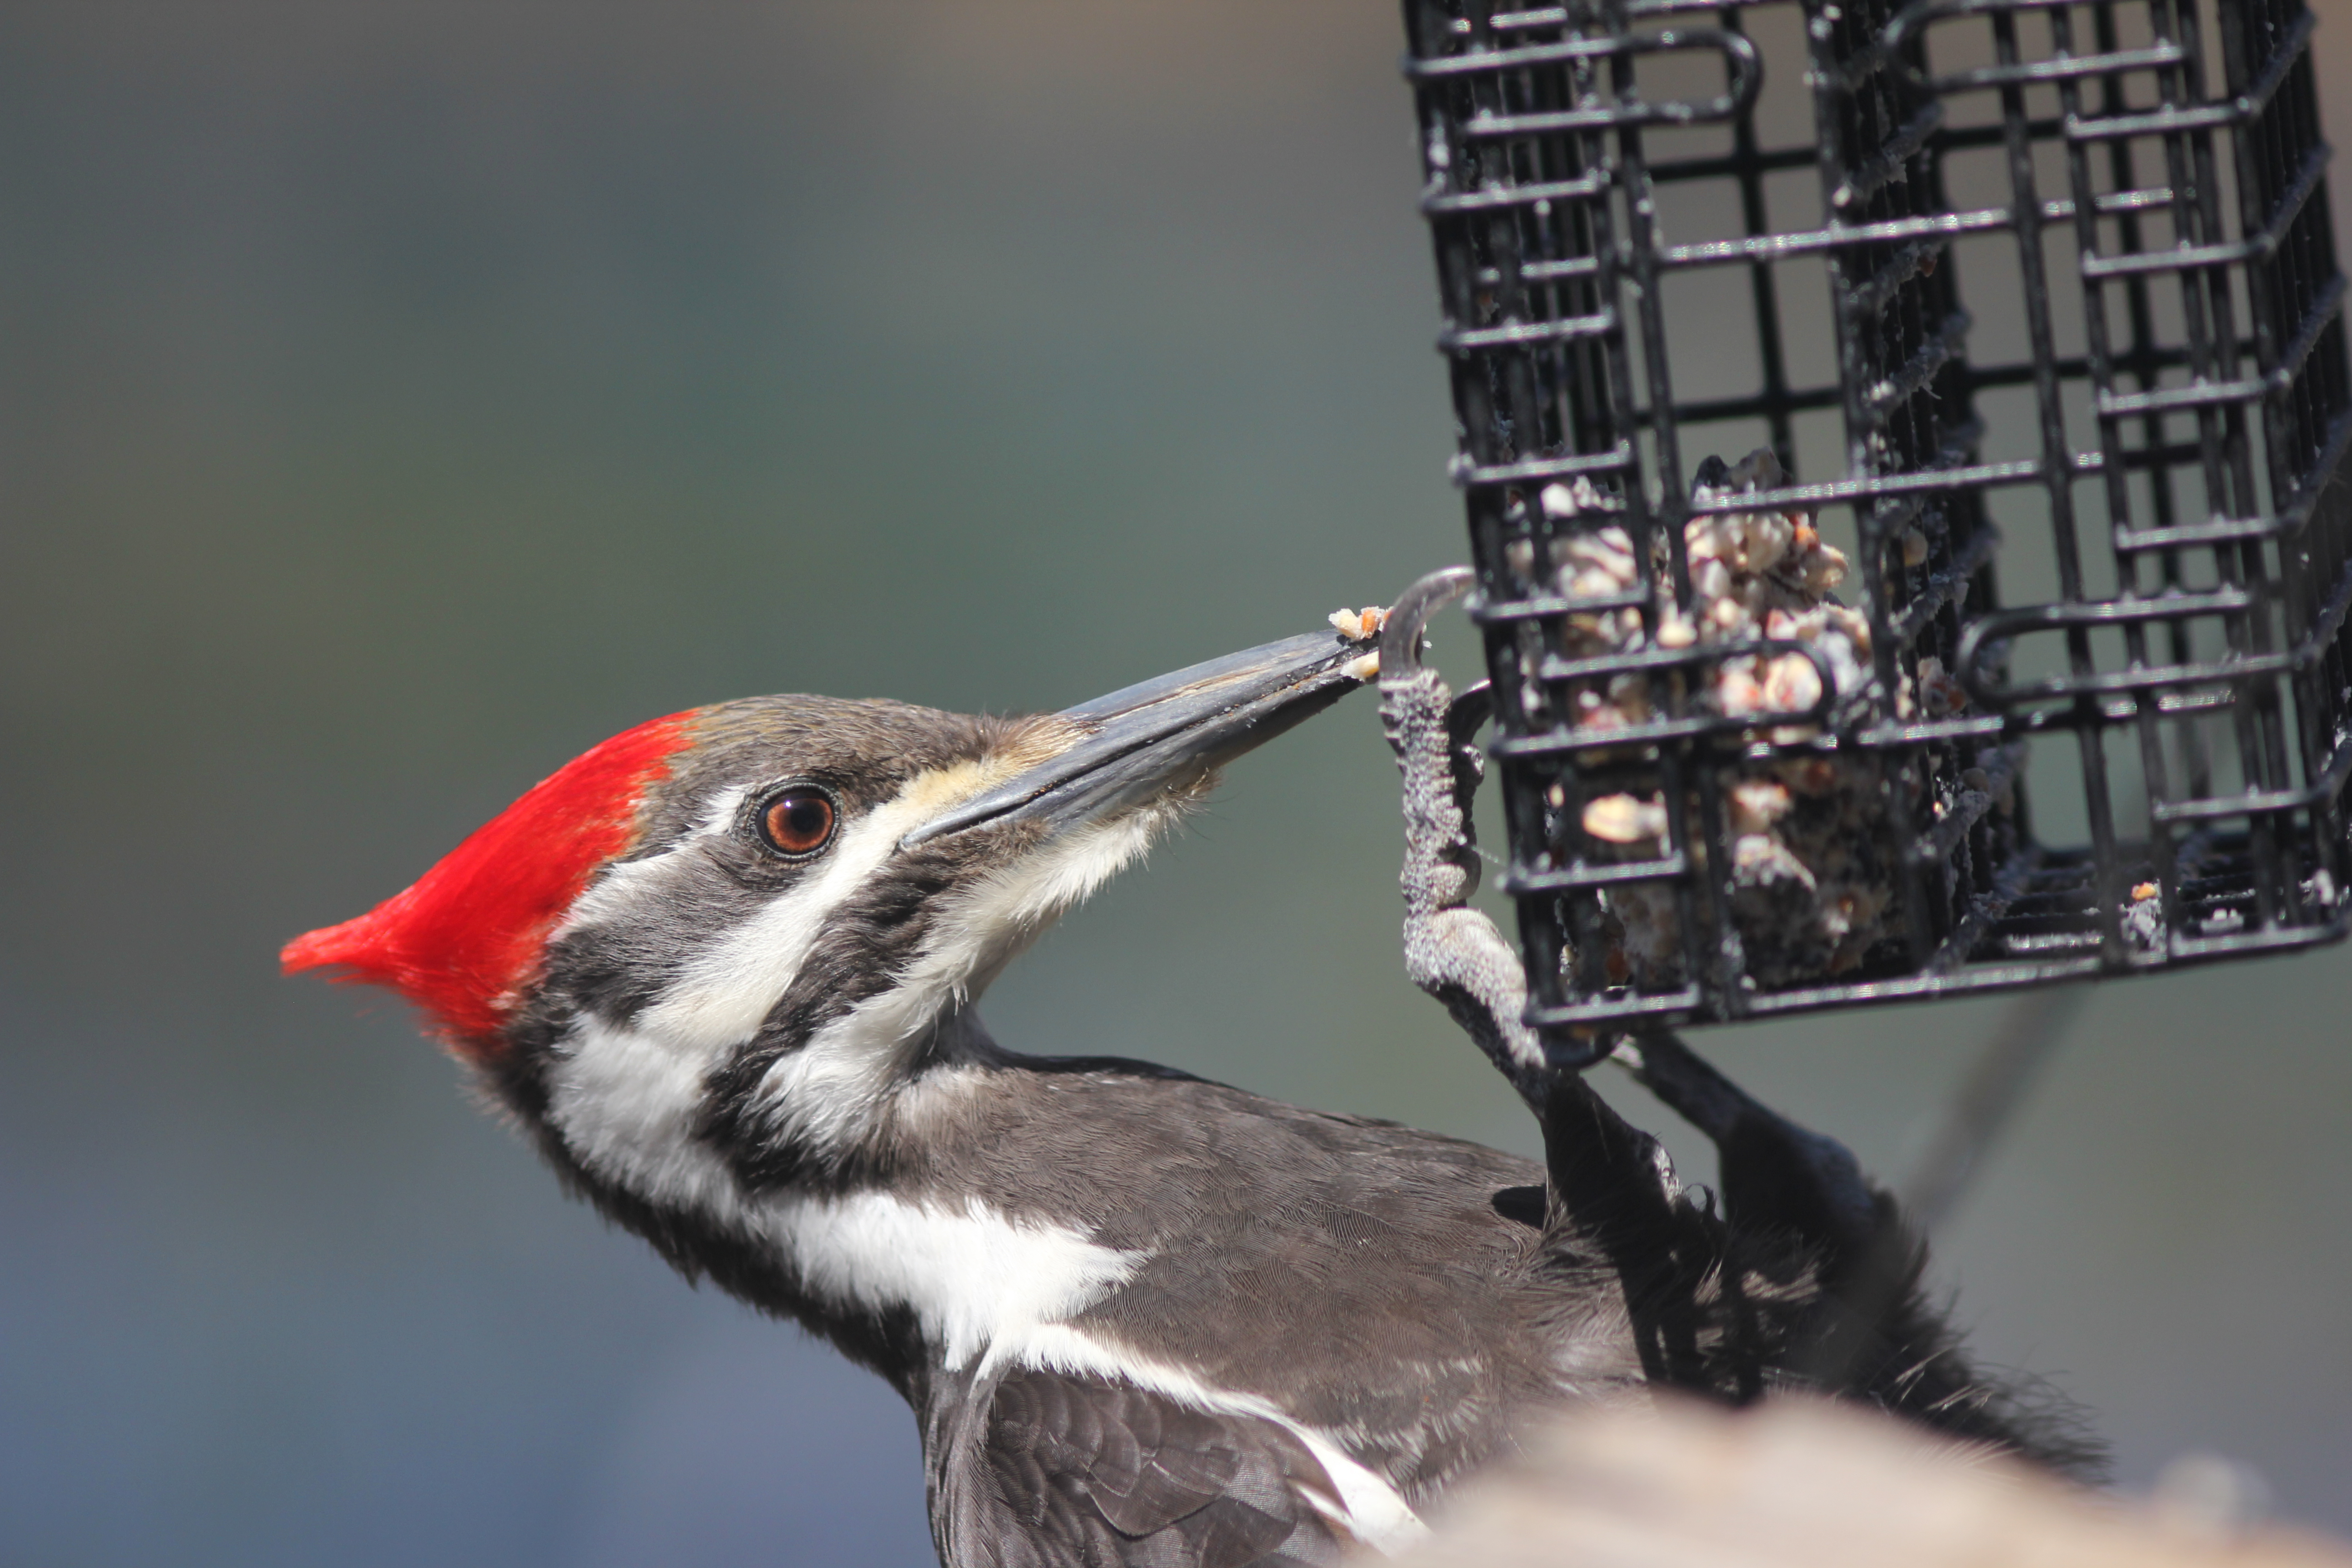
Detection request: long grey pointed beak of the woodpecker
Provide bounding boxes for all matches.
[898,632,1378,848]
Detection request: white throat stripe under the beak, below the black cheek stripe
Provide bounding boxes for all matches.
[760,808,1174,1147]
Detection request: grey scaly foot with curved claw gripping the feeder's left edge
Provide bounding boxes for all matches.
[1381,567,1557,1114]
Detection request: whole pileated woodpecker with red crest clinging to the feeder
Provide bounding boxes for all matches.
[284,573,2074,1568]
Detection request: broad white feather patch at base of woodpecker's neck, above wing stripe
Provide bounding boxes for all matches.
[764,1192,1136,1371]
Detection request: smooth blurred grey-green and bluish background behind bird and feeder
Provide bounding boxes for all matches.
[0,0,2352,1568]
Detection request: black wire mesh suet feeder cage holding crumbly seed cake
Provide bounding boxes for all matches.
[1404,0,2352,1055]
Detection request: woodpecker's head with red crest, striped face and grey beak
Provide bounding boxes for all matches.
[282,632,1371,1210]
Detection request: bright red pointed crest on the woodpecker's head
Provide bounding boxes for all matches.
[278,712,694,1053]
